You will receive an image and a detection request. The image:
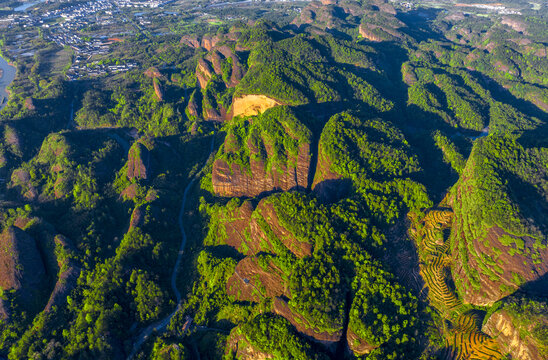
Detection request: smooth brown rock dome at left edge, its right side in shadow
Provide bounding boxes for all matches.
[0,226,46,304]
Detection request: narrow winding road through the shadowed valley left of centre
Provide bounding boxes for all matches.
[127,134,215,360]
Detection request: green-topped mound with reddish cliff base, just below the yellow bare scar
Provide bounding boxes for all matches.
[212,107,312,197]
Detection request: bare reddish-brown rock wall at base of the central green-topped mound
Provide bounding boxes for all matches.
[212,139,311,197]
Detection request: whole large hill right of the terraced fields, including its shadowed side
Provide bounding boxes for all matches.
[450,137,548,306]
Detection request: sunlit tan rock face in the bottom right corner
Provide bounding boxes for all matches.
[483,309,546,360]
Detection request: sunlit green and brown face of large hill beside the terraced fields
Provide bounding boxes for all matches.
[450,162,548,306]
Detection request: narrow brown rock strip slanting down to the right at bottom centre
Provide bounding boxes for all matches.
[272,297,342,347]
